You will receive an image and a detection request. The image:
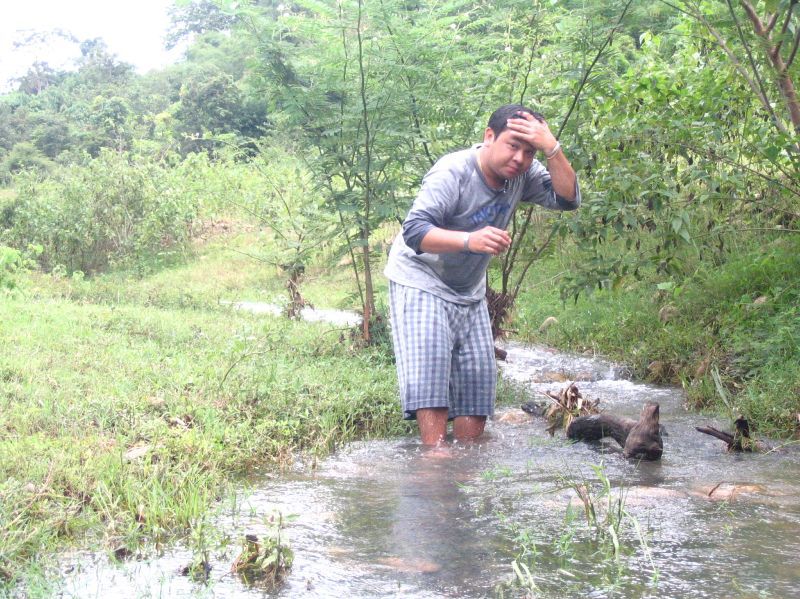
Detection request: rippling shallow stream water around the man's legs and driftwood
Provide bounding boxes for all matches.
[61,345,800,598]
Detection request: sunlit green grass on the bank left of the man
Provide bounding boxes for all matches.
[0,260,407,588]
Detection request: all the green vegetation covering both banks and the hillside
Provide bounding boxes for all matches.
[0,0,800,592]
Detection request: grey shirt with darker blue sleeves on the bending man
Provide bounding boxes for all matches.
[384,144,581,304]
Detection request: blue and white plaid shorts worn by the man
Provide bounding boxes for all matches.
[389,281,497,420]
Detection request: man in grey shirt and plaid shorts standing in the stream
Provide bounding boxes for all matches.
[385,104,580,445]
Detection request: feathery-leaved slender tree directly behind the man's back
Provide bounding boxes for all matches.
[239,0,576,340]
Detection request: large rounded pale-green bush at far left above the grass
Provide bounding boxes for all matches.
[5,151,198,273]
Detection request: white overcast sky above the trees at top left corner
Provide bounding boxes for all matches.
[0,0,180,91]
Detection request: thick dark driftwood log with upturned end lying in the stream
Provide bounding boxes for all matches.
[567,403,664,460]
